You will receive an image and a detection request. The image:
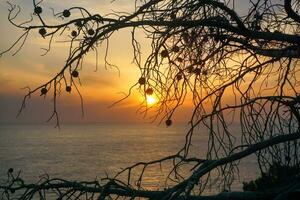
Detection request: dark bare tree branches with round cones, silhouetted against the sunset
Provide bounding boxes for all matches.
[0,0,300,199]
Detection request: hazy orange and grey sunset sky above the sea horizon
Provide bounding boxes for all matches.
[0,0,248,123]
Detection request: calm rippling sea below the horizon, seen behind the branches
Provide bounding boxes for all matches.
[0,123,257,193]
